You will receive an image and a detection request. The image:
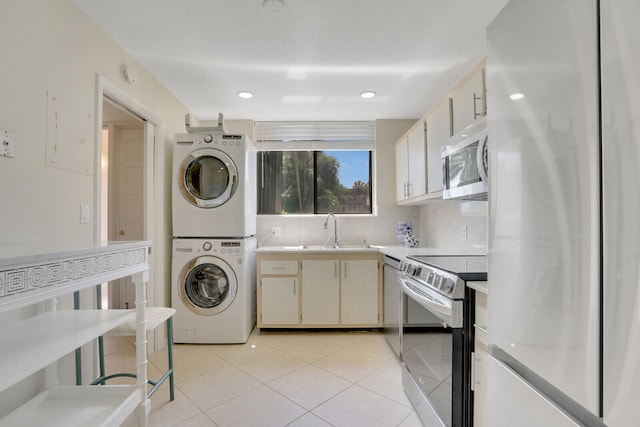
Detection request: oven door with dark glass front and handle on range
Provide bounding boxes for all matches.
[401,277,468,427]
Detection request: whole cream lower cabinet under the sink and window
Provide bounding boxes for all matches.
[256,251,382,328]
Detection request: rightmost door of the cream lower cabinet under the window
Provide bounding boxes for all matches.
[340,260,379,325]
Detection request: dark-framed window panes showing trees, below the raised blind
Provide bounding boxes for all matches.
[258,150,372,214]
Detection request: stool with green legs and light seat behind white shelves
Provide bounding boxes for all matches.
[91,307,176,400]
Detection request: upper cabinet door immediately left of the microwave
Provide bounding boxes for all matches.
[427,102,451,193]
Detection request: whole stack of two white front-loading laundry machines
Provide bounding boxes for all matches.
[171,119,257,344]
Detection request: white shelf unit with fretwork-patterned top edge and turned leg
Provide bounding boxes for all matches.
[0,242,150,427]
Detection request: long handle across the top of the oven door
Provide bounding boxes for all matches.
[400,277,463,328]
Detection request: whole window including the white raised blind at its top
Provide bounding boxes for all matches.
[256,122,374,215]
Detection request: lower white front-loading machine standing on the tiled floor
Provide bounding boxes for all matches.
[171,237,256,344]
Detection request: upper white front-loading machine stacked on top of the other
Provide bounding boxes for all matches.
[172,132,257,238]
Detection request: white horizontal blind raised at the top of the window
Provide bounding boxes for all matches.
[255,121,375,151]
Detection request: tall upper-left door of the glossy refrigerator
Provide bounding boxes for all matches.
[487,0,604,418]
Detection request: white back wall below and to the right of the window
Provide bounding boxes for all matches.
[257,120,419,246]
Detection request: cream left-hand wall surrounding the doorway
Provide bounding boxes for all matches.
[0,0,187,416]
